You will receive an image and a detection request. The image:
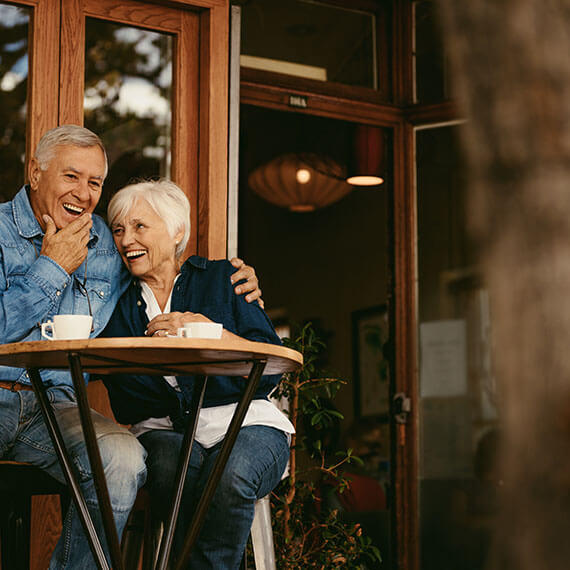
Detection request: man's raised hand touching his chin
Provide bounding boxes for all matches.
[40,214,93,275]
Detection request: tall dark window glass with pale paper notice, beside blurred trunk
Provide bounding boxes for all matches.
[416,126,496,570]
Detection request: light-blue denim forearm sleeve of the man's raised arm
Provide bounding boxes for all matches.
[0,253,71,344]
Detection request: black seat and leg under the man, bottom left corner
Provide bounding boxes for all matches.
[0,460,69,570]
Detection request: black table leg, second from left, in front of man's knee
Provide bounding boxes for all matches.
[68,352,123,570]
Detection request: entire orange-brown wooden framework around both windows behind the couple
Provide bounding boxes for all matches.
[12,0,229,257]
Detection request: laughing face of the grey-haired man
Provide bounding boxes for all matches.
[30,145,105,230]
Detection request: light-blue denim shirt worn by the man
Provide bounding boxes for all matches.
[0,186,129,386]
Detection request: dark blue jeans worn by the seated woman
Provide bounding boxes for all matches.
[139,426,289,570]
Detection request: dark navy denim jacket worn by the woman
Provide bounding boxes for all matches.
[103,255,281,427]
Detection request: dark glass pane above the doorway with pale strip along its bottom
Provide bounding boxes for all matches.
[241,0,382,89]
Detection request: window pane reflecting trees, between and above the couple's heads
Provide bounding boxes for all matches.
[84,18,172,213]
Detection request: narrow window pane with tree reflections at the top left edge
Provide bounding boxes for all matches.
[0,4,30,202]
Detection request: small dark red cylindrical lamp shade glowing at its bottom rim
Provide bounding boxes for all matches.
[346,125,386,186]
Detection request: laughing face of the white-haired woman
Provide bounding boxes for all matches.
[111,200,182,281]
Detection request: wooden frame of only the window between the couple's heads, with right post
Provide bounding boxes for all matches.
[59,0,228,257]
